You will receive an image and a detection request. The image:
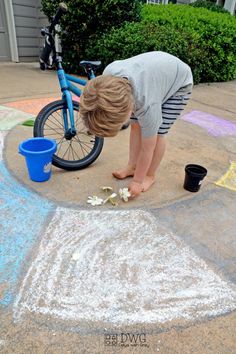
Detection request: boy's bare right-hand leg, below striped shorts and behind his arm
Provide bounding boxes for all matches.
[143,134,166,192]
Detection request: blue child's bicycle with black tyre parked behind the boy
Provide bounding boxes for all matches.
[34,3,104,170]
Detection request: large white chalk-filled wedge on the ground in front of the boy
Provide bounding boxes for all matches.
[13,208,236,325]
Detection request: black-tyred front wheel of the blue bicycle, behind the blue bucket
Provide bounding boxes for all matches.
[34,100,104,171]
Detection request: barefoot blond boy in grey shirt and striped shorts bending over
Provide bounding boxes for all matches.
[80,51,193,197]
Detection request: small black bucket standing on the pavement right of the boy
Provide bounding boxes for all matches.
[184,164,207,192]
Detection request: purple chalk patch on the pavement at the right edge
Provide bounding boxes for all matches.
[181,110,236,137]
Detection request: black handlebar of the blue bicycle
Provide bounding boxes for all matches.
[40,2,68,70]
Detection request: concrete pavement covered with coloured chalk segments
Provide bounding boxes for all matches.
[0,63,236,354]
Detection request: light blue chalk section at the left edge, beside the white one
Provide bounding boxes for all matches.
[0,161,55,306]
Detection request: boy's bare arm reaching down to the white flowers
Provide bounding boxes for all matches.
[129,135,157,197]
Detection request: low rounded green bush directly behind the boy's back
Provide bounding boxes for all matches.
[86,21,204,82]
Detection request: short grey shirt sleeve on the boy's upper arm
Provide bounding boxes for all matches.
[137,103,162,138]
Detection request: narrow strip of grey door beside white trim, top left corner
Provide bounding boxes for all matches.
[0,0,10,61]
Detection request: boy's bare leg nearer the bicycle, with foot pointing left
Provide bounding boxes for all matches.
[112,122,141,179]
